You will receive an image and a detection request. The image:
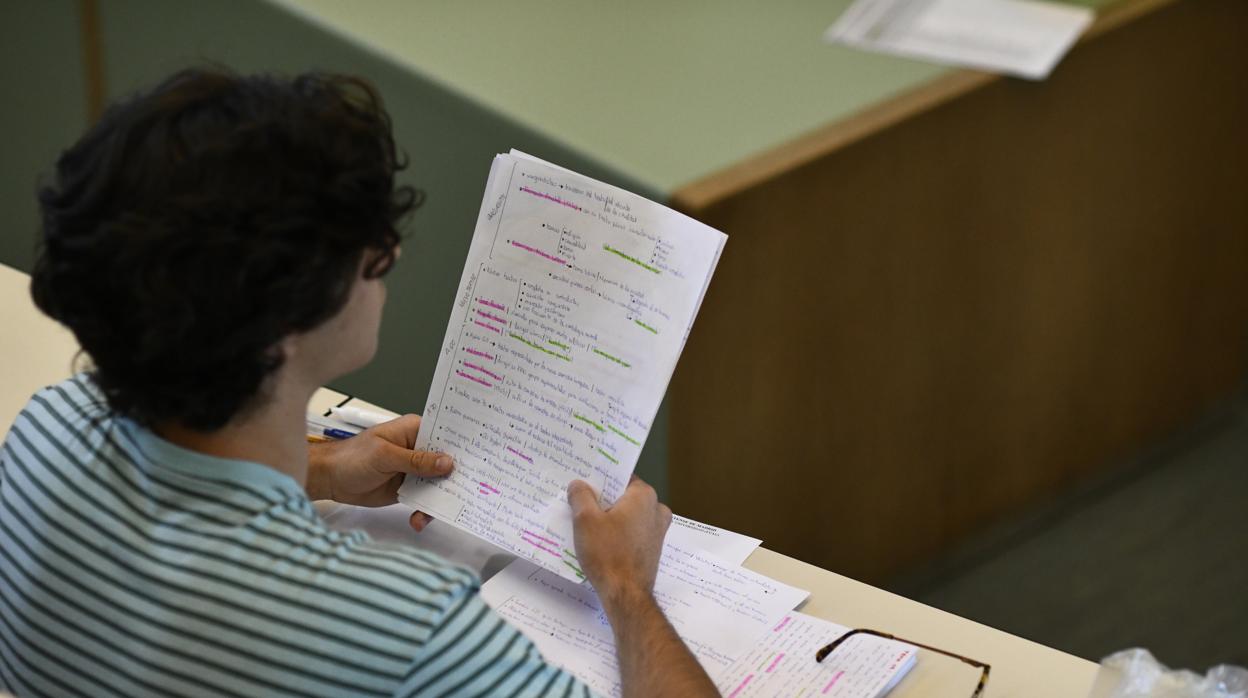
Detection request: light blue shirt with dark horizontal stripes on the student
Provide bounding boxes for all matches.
[0,375,589,697]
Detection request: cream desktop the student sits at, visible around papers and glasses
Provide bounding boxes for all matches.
[0,265,1112,698]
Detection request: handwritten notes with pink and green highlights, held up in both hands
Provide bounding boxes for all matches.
[399,151,726,579]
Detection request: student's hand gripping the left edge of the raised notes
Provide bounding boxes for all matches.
[305,415,454,531]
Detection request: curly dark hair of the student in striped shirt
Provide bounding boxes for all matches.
[31,67,423,431]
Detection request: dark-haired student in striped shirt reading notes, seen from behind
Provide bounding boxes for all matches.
[0,70,715,696]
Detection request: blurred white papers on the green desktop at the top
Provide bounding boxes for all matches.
[824,0,1093,80]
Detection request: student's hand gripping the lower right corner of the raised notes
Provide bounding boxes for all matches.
[568,477,671,604]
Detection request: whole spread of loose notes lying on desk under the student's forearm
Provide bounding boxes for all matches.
[480,517,917,698]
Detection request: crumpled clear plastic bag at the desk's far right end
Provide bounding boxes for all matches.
[1101,648,1248,698]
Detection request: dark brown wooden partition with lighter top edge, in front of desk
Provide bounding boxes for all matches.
[669,0,1248,581]
